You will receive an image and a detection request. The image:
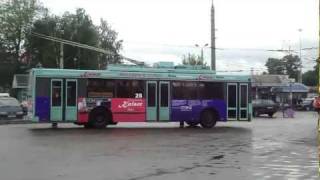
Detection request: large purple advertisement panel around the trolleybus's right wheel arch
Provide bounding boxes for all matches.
[171,100,227,121]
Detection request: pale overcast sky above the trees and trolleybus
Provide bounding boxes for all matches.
[41,0,318,73]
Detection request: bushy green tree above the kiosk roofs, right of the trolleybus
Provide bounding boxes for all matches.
[265,54,301,80]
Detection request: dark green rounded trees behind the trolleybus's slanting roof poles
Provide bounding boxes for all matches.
[28,9,122,69]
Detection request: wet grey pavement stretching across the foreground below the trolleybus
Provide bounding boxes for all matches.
[0,112,318,180]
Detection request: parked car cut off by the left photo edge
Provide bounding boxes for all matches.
[0,97,23,119]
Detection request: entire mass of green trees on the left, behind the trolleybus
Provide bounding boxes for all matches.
[0,0,122,91]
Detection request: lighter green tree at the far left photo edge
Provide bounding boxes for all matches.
[0,0,42,91]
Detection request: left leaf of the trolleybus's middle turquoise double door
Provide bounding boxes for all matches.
[146,81,158,121]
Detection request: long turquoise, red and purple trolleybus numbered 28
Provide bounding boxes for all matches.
[30,65,252,128]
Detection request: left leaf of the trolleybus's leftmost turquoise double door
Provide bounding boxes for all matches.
[50,79,63,121]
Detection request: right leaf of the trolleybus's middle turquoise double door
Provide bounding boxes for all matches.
[159,81,170,121]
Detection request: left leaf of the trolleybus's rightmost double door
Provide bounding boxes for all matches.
[227,83,238,120]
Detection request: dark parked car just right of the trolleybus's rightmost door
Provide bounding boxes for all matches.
[252,99,279,117]
